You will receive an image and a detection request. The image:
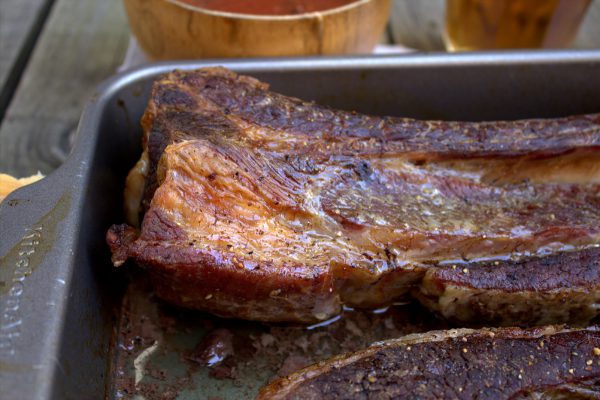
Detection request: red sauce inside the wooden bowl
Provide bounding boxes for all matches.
[176,0,357,15]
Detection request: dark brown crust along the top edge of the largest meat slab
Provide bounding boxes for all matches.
[142,68,600,206]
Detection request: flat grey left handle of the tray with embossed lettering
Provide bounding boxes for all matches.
[0,163,83,399]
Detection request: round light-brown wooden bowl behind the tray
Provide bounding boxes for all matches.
[124,0,390,60]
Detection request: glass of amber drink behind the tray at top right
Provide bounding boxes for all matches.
[446,0,591,51]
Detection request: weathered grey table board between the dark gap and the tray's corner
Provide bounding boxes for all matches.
[0,0,129,176]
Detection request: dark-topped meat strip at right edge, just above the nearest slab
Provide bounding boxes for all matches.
[413,248,600,326]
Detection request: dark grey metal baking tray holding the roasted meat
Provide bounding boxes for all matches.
[0,51,600,399]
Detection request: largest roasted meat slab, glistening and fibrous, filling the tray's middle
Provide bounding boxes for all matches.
[107,68,600,325]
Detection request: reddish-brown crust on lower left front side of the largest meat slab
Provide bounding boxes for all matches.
[107,209,341,323]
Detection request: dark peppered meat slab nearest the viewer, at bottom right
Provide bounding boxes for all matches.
[258,327,600,400]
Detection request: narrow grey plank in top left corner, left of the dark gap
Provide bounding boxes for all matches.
[0,0,53,120]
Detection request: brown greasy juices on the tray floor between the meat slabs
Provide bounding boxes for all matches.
[111,273,446,400]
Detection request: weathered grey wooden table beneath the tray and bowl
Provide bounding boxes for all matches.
[0,0,600,176]
